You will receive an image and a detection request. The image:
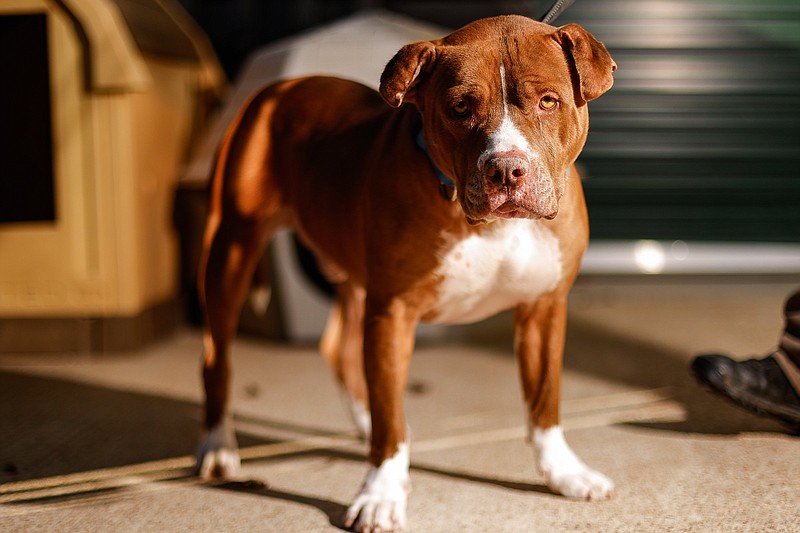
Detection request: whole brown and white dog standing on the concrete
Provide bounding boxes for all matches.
[198,16,616,532]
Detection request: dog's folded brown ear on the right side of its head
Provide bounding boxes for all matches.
[555,24,617,105]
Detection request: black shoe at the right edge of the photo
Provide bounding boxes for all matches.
[692,354,800,431]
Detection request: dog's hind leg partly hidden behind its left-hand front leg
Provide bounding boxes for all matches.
[320,281,371,440]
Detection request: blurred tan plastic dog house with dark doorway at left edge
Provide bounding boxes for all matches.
[0,0,225,351]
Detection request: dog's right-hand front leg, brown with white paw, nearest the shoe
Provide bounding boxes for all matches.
[515,293,614,500]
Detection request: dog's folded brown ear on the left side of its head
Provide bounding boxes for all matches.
[380,41,436,107]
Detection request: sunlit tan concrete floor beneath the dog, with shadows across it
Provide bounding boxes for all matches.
[0,277,800,533]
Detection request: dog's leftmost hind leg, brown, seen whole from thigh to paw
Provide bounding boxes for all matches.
[196,91,279,478]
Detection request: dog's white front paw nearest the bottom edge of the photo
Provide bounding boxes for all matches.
[345,444,411,533]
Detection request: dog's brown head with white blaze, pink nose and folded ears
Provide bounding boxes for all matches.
[380,16,617,223]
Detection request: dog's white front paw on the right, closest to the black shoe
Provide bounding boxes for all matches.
[531,426,614,501]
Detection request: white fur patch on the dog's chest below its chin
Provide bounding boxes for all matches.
[432,220,562,324]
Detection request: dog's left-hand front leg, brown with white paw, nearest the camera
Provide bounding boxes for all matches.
[345,298,416,533]
